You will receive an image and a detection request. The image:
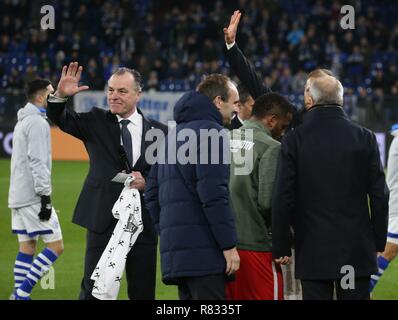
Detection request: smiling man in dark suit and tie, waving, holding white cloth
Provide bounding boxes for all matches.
[48,62,166,300]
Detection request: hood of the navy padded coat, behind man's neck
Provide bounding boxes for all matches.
[174,91,223,126]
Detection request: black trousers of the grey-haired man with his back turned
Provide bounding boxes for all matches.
[301,277,370,300]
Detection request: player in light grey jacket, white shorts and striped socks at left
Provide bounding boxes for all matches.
[8,79,64,300]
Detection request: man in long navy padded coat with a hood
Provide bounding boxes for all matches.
[145,74,239,300]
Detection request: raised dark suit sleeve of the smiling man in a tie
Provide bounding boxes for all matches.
[47,100,90,141]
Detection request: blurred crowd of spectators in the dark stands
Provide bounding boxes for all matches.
[0,0,398,127]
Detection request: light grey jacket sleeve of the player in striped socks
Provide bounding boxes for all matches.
[26,119,51,196]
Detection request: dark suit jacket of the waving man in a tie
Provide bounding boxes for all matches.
[47,102,167,243]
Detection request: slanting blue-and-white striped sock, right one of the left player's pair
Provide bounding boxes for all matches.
[17,248,58,297]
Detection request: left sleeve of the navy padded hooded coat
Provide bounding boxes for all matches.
[144,163,160,234]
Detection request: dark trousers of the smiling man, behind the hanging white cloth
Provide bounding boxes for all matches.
[79,225,157,300]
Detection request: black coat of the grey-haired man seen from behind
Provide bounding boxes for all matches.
[272,106,388,280]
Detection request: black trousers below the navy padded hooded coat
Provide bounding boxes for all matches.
[178,274,226,300]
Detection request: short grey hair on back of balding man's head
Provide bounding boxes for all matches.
[309,75,344,106]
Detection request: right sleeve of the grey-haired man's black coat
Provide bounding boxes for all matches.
[368,133,389,252]
